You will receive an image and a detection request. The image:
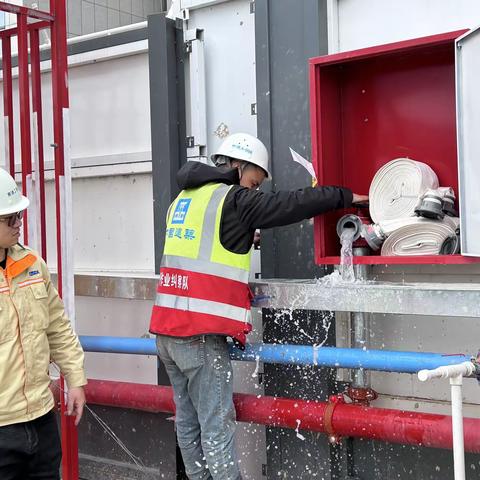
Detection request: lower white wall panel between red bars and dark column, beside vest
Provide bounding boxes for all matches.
[47,174,154,275]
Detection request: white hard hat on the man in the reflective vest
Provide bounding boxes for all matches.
[211,133,272,178]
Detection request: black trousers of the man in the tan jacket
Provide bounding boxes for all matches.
[0,411,62,480]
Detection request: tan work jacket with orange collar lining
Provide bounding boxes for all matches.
[0,245,87,426]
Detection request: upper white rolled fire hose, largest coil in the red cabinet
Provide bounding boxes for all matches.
[369,158,438,224]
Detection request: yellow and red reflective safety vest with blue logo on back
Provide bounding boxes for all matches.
[150,183,252,345]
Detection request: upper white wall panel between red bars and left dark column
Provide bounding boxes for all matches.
[70,53,151,158]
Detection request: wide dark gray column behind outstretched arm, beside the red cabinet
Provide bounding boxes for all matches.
[255,0,344,480]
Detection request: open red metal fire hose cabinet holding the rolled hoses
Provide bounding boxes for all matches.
[310,30,480,264]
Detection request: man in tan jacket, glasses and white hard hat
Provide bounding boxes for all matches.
[0,168,87,480]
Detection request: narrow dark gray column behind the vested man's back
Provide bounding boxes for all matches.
[148,14,187,480]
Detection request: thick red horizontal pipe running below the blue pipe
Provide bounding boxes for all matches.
[54,380,480,453]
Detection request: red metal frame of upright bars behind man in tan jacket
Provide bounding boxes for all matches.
[0,0,78,480]
